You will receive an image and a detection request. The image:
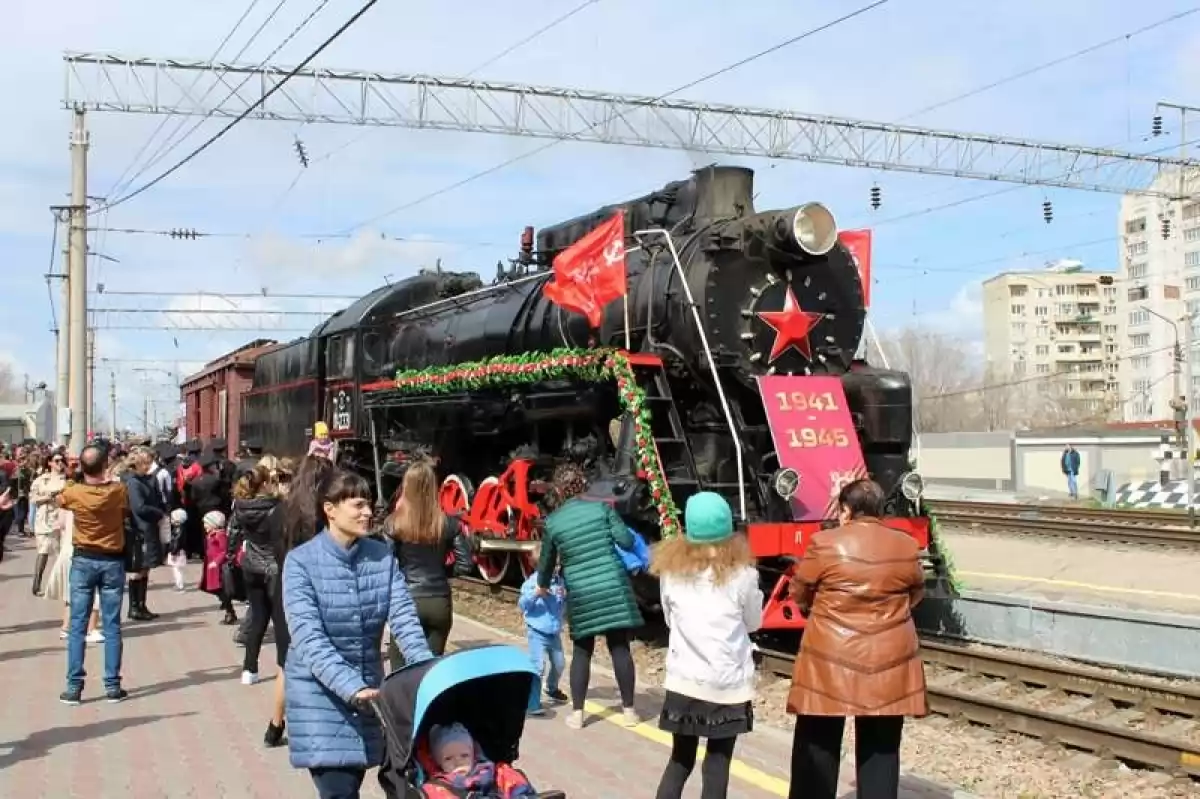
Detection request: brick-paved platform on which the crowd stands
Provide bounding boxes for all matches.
[0,539,961,799]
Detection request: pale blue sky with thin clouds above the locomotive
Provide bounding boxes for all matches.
[0,0,1200,427]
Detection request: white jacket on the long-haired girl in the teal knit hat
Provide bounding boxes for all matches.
[660,566,762,704]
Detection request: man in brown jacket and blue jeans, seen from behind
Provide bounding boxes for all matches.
[59,444,130,704]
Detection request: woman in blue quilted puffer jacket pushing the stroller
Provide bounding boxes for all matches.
[283,471,433,799]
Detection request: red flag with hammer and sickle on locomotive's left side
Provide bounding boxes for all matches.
[542,211,625,328]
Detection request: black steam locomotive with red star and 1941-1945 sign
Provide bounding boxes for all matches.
[240,167,946,630]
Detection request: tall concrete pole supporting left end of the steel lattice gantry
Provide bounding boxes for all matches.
[67,108,90,453]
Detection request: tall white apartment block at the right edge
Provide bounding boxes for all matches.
[1117,165,1200,421]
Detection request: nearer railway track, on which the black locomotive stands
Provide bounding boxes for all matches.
[458,578,1200,779]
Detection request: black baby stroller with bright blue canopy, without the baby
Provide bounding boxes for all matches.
[373,645,566,799]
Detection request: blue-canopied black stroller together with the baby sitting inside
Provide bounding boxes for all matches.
[373,645,566,799]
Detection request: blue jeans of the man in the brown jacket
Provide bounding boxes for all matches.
[67,552,125,691]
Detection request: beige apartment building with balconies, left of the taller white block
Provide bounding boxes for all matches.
[983,262,1120,419]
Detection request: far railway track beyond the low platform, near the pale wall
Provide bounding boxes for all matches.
[929,500,1200,547]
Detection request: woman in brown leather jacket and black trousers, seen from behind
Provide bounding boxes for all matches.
[787,480,928,799]
